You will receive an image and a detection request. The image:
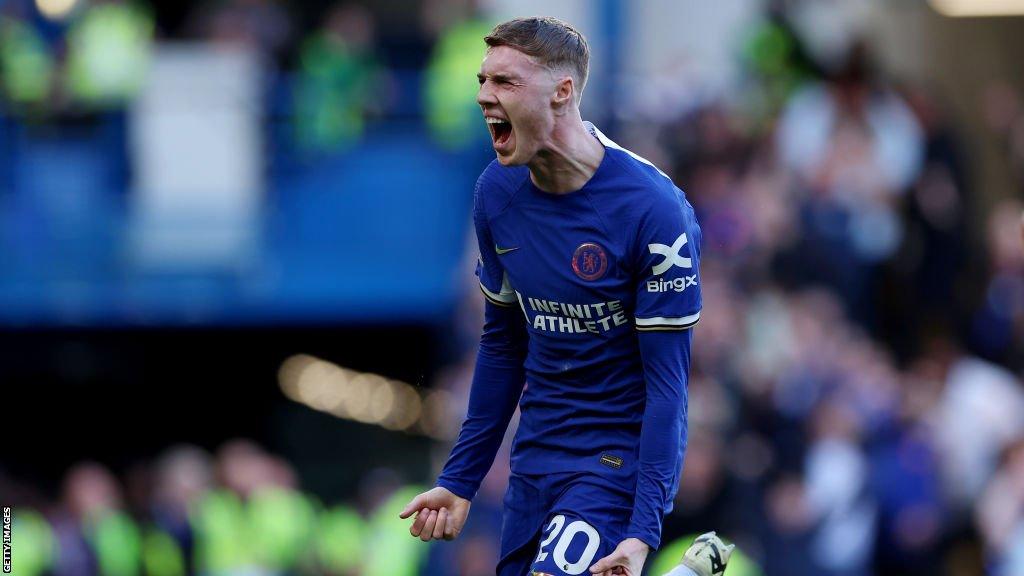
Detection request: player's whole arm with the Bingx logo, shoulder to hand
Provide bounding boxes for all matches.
[591,188,702,574]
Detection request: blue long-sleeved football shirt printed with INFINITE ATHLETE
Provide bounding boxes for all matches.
[438,123,701,546]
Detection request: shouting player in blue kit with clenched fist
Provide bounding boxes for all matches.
[402,17,701,576]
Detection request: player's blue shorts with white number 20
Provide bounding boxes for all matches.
[497,472,634,576]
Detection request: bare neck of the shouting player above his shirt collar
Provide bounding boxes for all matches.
[527,114,604,194]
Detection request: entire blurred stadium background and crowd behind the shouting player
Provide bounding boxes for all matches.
[0,0,1024,576]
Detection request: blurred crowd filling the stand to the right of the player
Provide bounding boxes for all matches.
[622,18,1024,576]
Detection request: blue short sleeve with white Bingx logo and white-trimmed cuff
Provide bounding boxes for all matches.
[635,190,702,331]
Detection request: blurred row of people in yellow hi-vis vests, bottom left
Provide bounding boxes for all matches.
[0,440,436,576]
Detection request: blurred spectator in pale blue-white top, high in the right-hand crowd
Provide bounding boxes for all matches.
[778,42,925,326]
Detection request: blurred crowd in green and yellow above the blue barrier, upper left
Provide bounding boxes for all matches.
[0,0,490,151]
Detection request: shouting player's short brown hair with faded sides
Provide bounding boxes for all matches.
[483,16,590,104]
